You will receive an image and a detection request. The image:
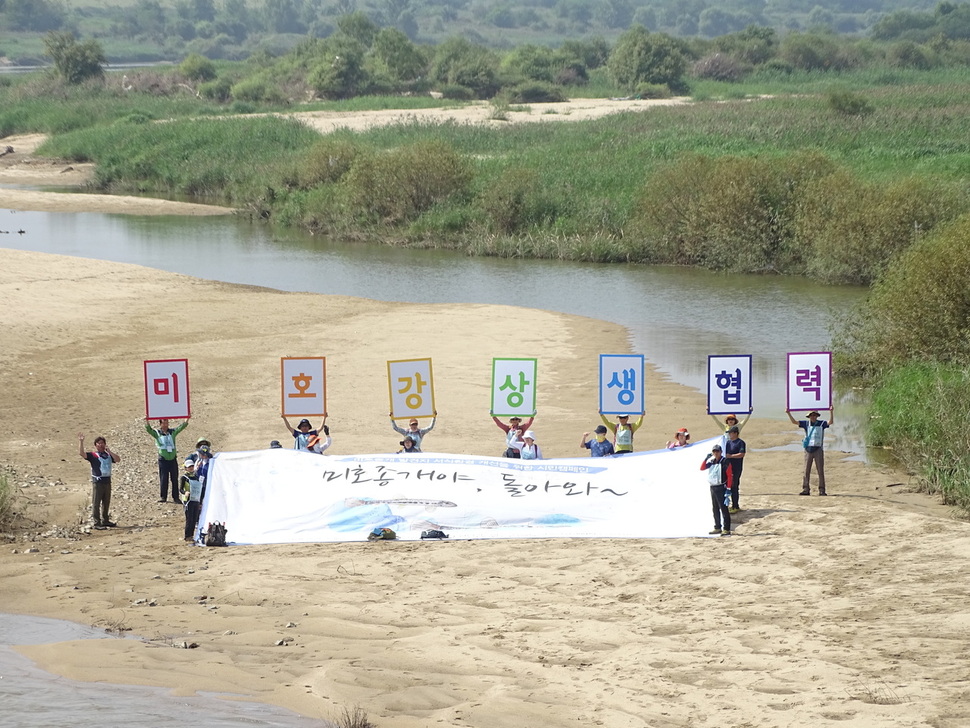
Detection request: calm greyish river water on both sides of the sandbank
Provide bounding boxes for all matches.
[0,202,865,728]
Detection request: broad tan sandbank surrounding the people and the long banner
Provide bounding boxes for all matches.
[0,106,970,728]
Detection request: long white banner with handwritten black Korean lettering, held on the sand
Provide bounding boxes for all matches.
[200,439,718,544]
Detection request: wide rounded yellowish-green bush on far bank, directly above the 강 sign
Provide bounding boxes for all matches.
[345,141,472,224]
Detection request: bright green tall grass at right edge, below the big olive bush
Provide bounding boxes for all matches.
[869,363,970,512]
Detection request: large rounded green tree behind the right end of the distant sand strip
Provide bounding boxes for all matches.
[607,25,688,93]
